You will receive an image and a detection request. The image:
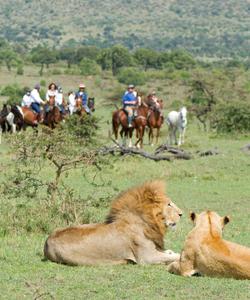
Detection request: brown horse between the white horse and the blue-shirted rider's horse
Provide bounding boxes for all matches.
[148,100,164,146]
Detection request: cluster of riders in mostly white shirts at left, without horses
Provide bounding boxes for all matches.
[21,82,91,122]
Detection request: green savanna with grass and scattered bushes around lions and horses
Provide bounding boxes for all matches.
[0,53,250,299]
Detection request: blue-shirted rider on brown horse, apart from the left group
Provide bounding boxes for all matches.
[122,84,137,128]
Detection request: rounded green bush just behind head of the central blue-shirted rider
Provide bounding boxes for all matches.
[117,68,147,85]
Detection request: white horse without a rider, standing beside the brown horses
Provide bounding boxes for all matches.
[166,106,187,146]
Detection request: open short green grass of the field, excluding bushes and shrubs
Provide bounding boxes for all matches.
[0,70,250,299]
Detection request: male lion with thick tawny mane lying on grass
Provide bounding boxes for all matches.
[44,181,182,265]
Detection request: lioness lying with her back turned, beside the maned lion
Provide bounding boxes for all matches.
[168,211,250,279]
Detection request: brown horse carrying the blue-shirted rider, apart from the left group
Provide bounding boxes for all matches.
[112,102,148,148]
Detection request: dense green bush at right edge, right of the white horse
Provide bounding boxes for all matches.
[211,101,250,133]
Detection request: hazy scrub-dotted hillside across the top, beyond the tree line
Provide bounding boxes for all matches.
[0,0,250,58]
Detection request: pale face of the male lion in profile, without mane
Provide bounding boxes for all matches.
[163,198,182,228]
